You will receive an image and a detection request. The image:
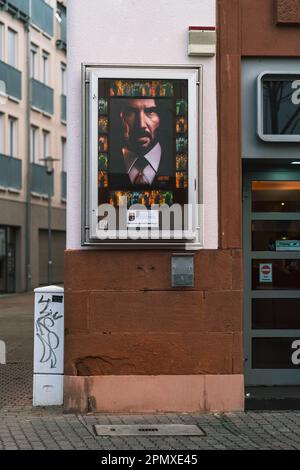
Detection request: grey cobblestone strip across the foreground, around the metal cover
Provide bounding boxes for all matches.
[0,406,300,451]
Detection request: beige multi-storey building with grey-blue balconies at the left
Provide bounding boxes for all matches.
[0,0,67,293]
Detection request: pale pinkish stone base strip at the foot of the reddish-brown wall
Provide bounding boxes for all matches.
[64,374,244,413]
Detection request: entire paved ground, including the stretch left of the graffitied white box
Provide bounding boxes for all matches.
[0,294,300,451]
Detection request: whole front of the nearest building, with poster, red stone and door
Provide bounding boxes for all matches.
[65,0,300,412]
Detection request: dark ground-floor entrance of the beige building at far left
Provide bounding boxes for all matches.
[0,226,16,294]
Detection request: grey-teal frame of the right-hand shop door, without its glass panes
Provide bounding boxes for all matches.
[243,169,300,385]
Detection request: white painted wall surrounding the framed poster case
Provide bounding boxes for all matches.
[67,0,218,249]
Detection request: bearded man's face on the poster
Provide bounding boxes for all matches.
[120,98,160,155]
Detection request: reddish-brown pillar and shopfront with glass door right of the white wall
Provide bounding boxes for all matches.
[218,0,300,407]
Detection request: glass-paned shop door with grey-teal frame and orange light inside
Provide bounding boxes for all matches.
[243,169,300,385]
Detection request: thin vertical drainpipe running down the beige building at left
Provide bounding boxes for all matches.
[25,1,32,292]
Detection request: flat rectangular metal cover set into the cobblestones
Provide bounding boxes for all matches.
[94,424,205,437]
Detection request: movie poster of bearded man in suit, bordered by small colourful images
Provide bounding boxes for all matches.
[98,78,189,226]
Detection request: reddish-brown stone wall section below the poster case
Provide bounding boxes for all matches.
[65,250,242,376]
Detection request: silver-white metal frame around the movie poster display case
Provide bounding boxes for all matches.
[81,63,204,250]
